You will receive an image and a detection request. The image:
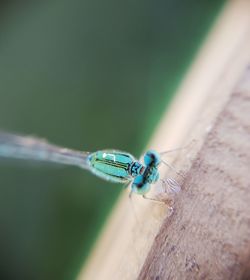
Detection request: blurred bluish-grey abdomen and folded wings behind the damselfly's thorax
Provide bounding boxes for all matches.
[0,132,90,169]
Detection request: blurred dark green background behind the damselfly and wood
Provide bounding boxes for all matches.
[0,0,224,279]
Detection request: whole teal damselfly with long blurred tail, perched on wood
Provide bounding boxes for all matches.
[0,132,183,198]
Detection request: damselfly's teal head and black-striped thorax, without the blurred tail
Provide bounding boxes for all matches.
[88,150,160,194]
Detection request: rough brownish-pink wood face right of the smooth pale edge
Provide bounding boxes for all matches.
[138,68,250,280]
